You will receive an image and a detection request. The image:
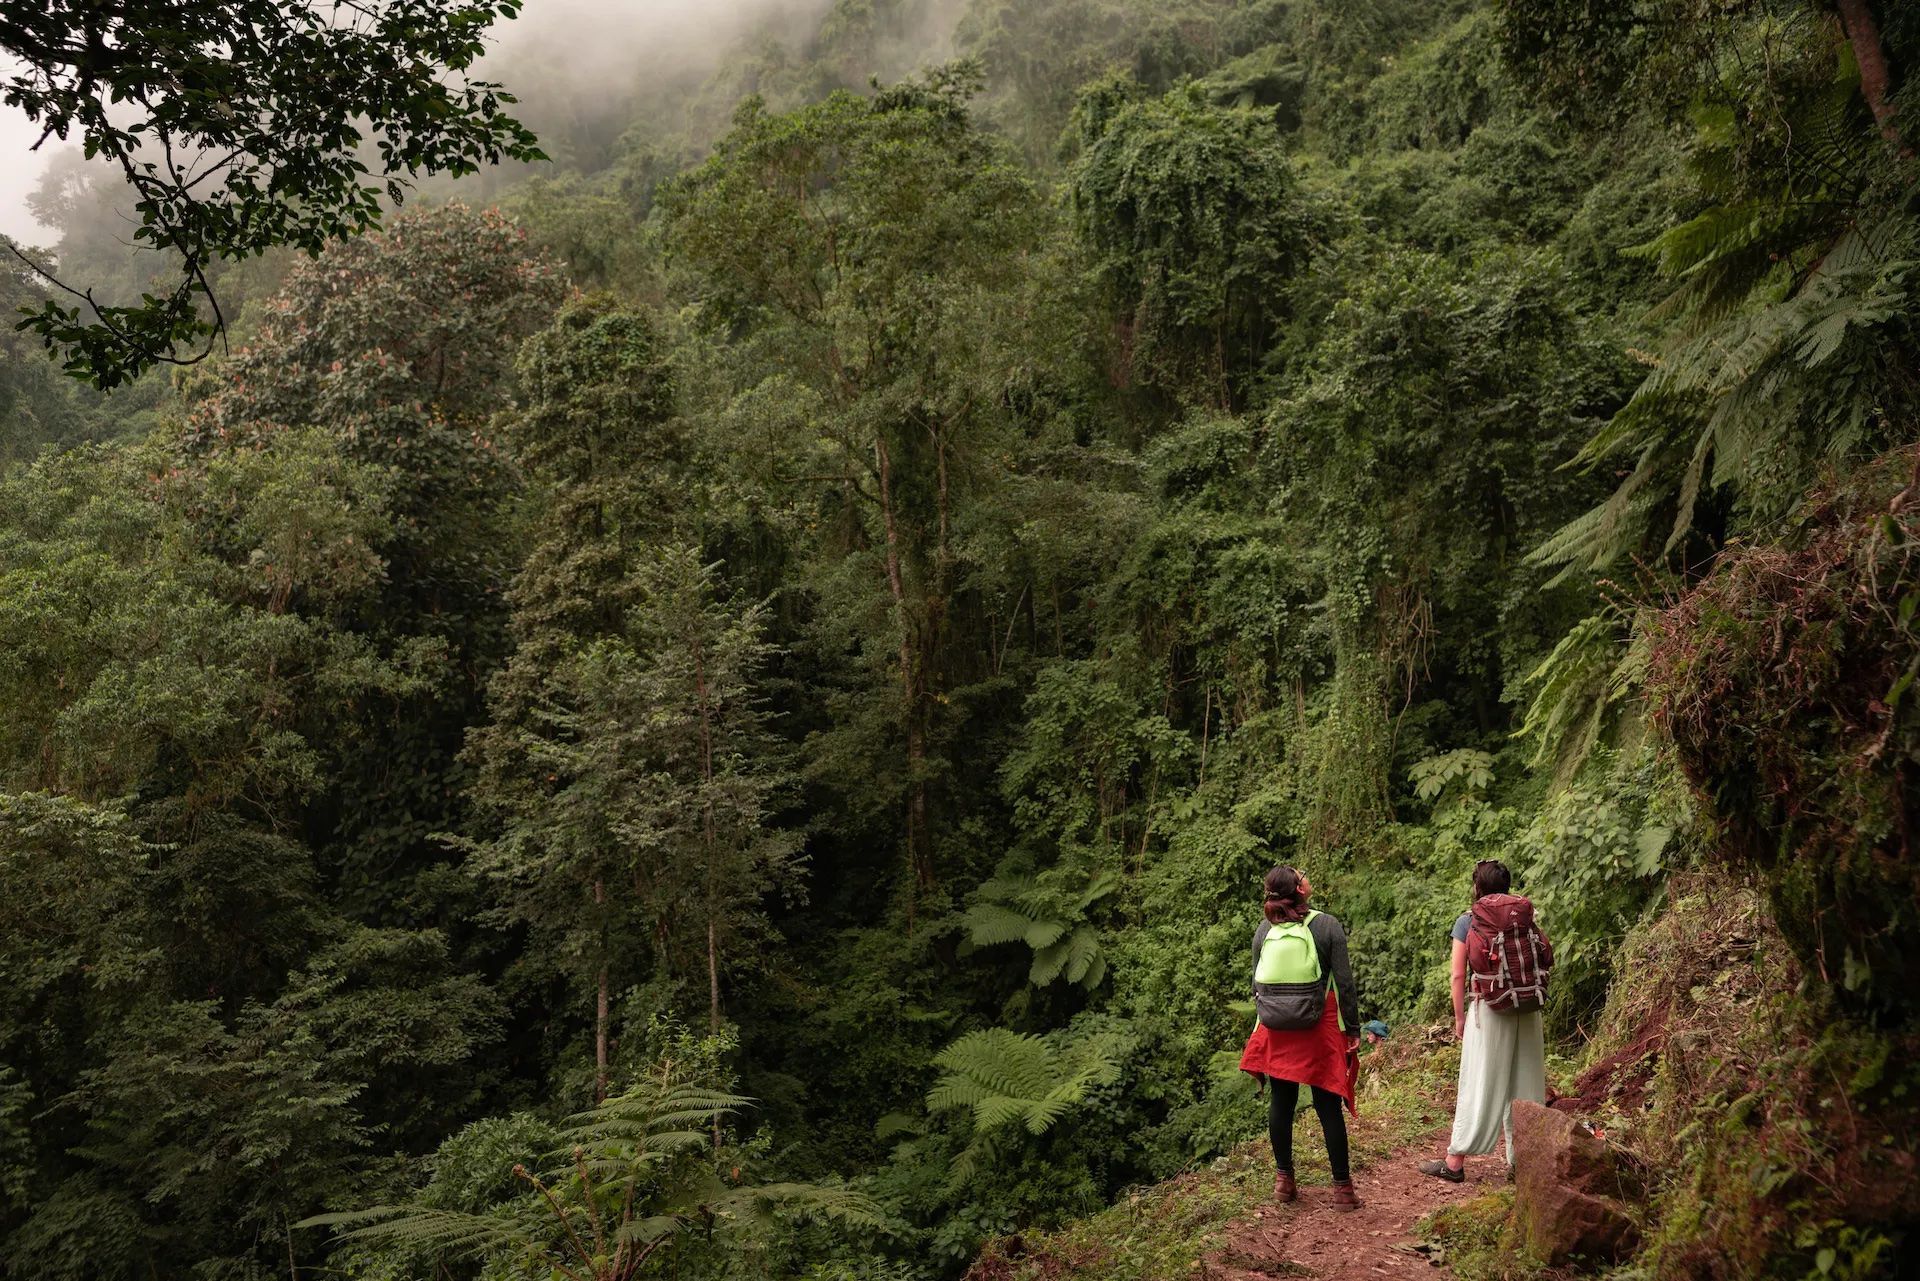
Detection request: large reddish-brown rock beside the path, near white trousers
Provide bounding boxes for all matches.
[1513,1099,1640,1264]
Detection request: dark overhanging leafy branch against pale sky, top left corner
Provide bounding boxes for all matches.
[0,0,541,388]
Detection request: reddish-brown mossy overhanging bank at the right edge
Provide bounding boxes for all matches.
[1647,447,1920,1012]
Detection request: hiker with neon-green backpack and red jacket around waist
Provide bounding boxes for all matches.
[1240,866,1359,1210]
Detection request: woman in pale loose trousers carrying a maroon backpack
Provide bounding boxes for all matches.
[1419,858,1553,1183]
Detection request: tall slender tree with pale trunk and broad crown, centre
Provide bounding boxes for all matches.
[664,63,1041,920]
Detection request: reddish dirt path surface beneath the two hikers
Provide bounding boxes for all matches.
[1200,1133,1507,1281]
